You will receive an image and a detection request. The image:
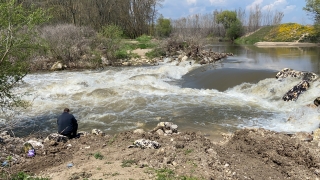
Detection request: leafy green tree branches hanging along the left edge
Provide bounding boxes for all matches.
[0,0,47,112]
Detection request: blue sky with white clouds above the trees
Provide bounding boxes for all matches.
[159,0,313,25]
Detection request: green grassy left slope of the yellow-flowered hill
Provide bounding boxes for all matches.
[235,26,274,45]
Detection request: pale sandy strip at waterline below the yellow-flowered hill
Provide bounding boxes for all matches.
[254,42,320,47]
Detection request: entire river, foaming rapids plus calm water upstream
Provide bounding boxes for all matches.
[4,44,320,137]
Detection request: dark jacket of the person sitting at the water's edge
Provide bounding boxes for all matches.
[57,112,78,135]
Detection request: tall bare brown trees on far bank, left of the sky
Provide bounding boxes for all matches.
[18,0,163,38]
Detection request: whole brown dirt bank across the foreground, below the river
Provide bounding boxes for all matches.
[1,129,320,180]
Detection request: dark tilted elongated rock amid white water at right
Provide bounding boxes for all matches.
[282,80,310,101]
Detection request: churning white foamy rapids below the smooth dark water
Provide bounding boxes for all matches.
[11,59,320,132]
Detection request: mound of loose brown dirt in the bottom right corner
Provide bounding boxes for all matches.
[217,129,319,179]
